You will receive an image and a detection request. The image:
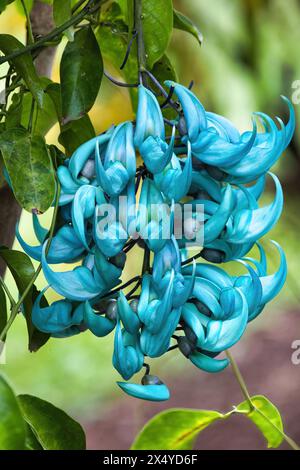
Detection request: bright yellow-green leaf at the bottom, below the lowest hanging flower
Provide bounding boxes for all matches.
[131,409,224,450]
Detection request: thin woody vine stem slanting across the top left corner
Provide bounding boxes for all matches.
[0,0,105,65]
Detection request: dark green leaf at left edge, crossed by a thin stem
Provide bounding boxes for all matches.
[0,247,49,351]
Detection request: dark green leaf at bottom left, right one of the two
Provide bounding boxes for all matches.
[18,395,86,450]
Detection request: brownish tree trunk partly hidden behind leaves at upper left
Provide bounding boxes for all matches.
[0,0,55,276]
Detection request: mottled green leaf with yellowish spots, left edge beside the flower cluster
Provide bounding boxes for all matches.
[0,128,55,212]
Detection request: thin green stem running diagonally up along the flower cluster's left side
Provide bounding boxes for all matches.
[0,183,60,341]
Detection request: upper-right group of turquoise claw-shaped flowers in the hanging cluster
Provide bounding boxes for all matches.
[165,81,295,183]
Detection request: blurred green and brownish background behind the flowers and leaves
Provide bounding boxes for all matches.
[0,0,300,449]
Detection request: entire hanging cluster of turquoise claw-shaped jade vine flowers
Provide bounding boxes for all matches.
[17,82,295,401]
